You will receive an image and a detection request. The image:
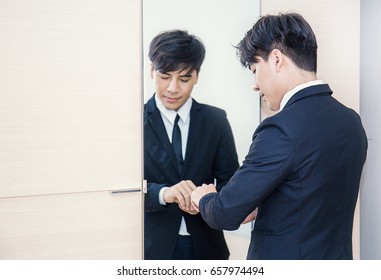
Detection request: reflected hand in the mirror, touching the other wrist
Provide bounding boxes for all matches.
[163,180,196,211]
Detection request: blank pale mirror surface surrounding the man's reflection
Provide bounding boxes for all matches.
[143,0,260,258]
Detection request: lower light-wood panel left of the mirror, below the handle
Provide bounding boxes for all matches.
[0,192,143,260]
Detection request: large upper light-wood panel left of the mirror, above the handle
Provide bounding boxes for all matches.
[0,0,142,197]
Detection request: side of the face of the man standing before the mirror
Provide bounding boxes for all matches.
[250,57,283,111]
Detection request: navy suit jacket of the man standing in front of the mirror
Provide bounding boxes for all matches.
[200,84,367,259]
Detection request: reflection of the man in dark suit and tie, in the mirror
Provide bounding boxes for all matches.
[144,30,239,259]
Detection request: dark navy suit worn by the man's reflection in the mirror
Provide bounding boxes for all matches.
[144,97,238,259]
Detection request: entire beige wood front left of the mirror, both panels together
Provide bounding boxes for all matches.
[0,0,142,259]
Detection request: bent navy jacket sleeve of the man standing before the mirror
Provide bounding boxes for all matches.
[199,119,294,230]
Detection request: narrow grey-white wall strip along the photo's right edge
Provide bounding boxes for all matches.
[360,0,381,259]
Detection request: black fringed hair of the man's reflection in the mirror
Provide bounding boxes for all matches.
[148,30,205,73]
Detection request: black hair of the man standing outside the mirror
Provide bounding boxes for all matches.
[236,13,317,72]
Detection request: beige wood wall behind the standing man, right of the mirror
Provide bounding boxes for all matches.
[261,0,360,259]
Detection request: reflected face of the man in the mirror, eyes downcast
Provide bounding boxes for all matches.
[151,66,198,110]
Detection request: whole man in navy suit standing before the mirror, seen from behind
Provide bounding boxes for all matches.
[192,13,367,259]
